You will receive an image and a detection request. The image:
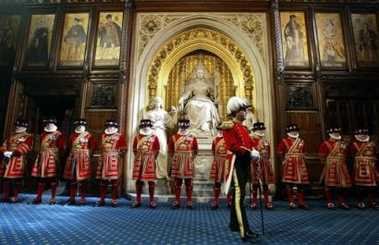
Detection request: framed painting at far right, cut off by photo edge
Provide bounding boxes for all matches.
[351,13,379,67]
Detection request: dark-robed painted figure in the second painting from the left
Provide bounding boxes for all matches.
[26,19,49,65]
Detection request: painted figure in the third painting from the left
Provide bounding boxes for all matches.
[63,17,87,60]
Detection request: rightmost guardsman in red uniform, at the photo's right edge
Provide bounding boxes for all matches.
[349,128,379,209]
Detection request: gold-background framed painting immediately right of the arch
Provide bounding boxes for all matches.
[280,11,310,68]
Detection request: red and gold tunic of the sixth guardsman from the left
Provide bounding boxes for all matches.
[168,133,198,179]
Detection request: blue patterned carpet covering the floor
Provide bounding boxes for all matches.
[0,195,379,244]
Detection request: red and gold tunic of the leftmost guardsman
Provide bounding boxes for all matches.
[0,132,33,179]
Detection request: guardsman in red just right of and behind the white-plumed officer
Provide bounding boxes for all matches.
[250,122,275,209]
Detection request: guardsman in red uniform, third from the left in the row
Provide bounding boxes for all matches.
[63,119,96,205]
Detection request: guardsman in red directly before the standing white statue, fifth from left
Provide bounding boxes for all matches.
[133,119,159,208]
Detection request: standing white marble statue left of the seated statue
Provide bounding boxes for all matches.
[145,97,175,178]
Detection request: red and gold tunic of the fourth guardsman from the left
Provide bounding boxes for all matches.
[96,133,126,180]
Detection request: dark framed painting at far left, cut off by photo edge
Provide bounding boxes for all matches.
[0,15,21,66]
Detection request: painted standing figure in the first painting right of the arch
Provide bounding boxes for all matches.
[284,15,304,64]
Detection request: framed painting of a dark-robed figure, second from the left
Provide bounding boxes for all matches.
[24,14,55,67]
